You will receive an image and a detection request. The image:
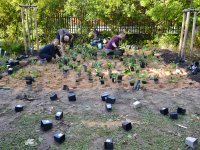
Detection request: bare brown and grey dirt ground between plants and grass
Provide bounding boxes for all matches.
[0,49,200,150]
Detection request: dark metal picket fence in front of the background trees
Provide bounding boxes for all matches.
[42,13,180,42]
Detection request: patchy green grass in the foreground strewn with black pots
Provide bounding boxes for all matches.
[0,110,200,150]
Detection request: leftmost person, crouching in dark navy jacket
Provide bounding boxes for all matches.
[39,39,61,62]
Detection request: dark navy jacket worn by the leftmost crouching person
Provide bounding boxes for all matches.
[39,44,61,58]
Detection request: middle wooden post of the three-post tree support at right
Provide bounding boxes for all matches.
[181,11,190,61]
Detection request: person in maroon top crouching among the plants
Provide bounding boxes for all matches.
[105,32,125,55]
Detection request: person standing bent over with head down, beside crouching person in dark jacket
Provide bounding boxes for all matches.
[56,28,74,54]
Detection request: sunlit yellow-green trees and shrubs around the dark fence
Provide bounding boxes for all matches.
[0,0,200,52]
